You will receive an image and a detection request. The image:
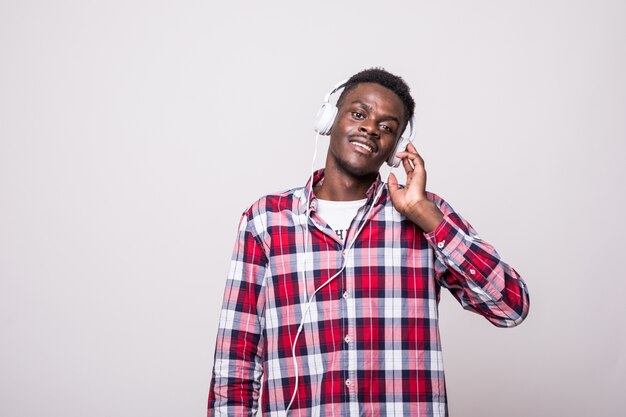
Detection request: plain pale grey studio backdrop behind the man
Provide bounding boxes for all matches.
[0,0,626,417]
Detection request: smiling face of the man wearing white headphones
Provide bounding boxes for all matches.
[326,83,406,177]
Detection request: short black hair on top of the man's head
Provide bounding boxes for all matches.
[337,68,415,124]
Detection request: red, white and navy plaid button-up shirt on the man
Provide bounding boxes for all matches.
[208,170,528,417]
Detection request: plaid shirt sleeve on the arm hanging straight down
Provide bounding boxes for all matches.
[207,215,267,416]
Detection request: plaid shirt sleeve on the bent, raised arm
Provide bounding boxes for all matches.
[424,194,529,327]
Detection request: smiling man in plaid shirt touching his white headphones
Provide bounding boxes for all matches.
[208,69,528,416]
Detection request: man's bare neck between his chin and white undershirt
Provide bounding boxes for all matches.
[315,166,377,201]
